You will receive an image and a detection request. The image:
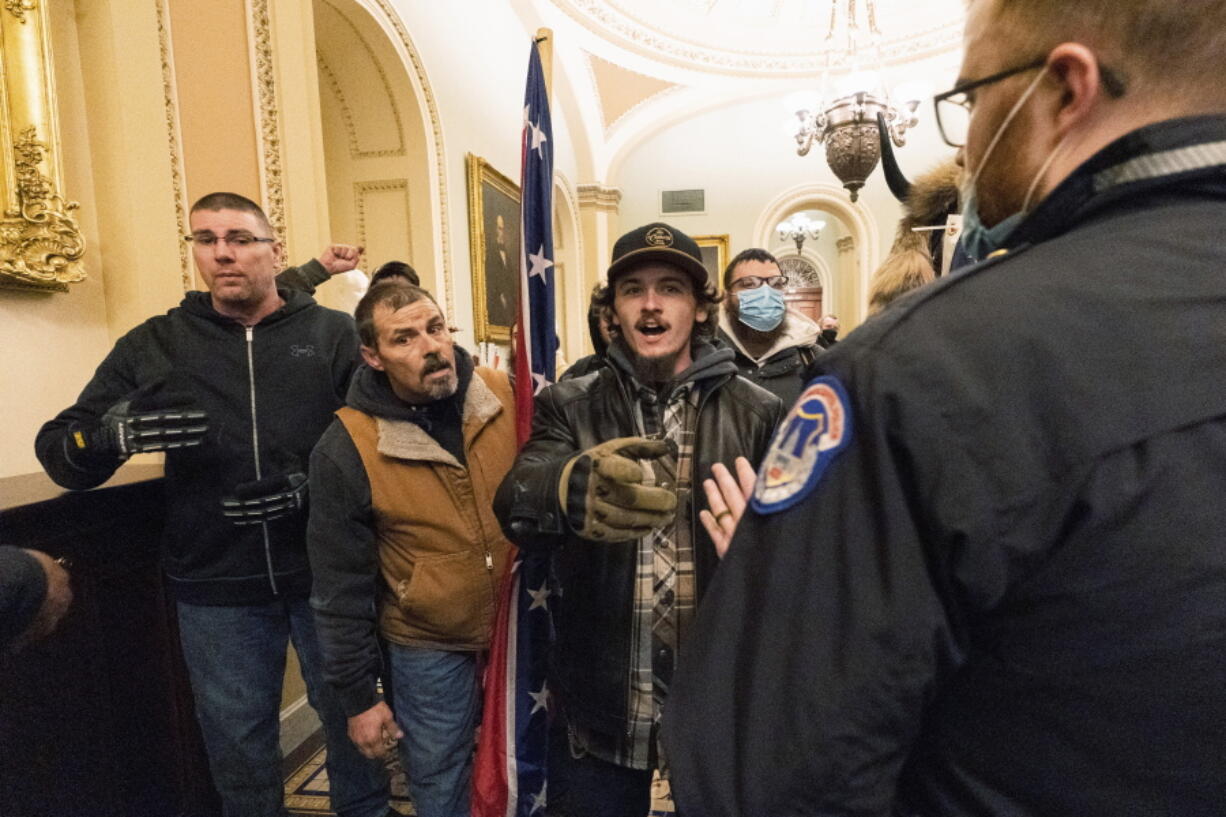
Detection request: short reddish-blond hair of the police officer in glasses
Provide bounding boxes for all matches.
[969,0,1226,105]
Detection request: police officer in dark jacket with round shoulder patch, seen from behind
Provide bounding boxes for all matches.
[666,0,1226,817]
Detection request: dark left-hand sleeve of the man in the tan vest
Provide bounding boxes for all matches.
[307,420,383,716]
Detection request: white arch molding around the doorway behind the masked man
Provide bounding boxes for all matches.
[754,183,879,320]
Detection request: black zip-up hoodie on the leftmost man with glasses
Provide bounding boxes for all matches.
[34,290,358,605]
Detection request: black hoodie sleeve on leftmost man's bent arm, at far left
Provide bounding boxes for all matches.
[34,329,141,491]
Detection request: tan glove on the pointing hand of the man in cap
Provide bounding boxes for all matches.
[558,437,677,542]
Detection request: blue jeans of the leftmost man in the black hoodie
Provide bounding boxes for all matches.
[179,599,387,817]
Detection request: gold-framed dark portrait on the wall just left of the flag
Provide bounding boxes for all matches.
[465,153,520,343]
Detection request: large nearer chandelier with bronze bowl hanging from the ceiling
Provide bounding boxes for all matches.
[796,0,920,201]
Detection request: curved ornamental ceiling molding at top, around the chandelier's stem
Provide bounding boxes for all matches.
[553,0,964,76]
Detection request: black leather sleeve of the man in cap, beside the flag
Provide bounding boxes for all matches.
[494,388,581,550]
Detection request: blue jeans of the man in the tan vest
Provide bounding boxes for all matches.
[387,644,481,817]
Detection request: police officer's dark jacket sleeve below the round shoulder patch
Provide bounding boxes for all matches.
[664,360,956,817]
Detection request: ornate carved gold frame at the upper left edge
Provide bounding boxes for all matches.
[0,0,86,292]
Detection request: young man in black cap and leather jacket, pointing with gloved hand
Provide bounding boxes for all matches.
[494,223,782,817]
